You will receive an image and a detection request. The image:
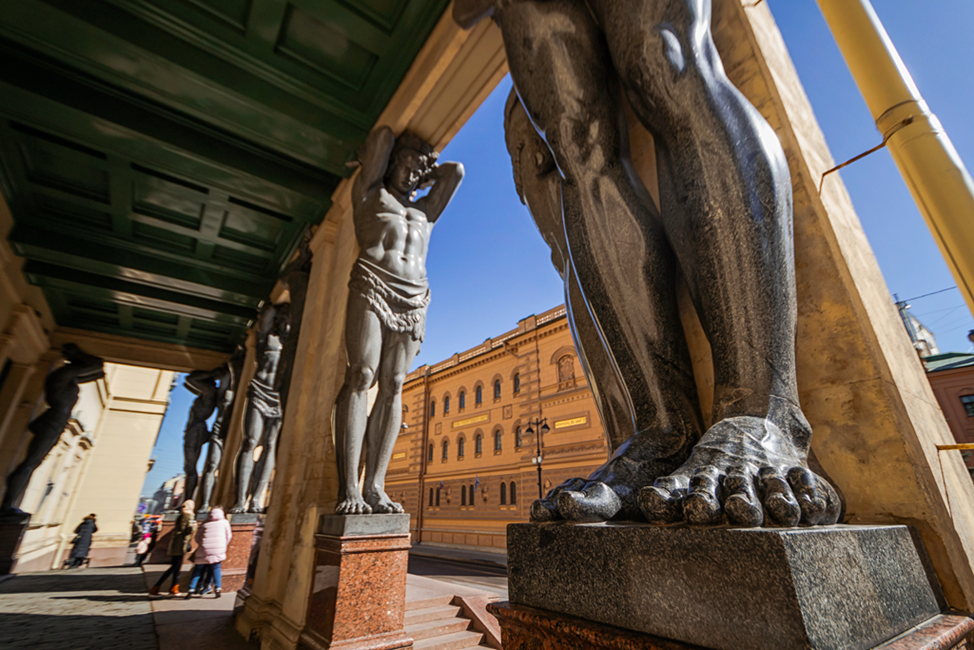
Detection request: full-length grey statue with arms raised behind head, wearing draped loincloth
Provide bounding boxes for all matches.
[335,127,463,515]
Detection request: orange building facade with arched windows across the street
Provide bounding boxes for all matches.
[386,306,608,549]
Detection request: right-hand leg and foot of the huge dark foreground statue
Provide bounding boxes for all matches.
[592,0,839,526]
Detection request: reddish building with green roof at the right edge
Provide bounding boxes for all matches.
[923,352,974,472]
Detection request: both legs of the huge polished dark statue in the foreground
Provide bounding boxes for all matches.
[468,0,841,527]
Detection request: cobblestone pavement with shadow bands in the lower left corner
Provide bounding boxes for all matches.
[0,567,159,650]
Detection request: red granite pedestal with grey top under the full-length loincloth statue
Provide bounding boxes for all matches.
[299,515,413,650]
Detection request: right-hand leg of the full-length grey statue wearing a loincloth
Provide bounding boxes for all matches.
[365,331,420,513]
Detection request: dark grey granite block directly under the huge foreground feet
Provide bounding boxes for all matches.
[505,523,940,650]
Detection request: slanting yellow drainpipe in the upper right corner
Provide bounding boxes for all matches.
[818,0,974,313]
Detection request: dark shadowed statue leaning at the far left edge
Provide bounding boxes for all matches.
[0,343,105,516]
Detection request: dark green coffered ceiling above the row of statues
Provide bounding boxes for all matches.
[0,0,447,350]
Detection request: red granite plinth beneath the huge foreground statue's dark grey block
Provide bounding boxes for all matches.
[487,602,974,650]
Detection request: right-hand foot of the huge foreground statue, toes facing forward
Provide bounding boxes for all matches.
[639,417,841,528]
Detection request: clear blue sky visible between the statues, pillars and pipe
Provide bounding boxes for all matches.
[143,0,974,494]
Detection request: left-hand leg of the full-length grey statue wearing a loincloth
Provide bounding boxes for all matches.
[335,292,382,515]
